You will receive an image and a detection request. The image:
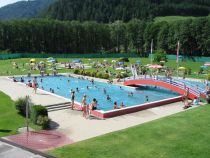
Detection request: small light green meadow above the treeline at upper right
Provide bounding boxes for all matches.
[154,16,198,23]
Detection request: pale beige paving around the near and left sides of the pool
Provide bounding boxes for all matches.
[0,77,187,146]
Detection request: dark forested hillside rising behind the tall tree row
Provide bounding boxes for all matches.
[43,0,210,22]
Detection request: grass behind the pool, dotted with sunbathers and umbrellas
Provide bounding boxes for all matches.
[0,58,206,78]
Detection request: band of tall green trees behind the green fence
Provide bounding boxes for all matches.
[0,17,210,56]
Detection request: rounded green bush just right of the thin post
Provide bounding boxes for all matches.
[31,105,48,124]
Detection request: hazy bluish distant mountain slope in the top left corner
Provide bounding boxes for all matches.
[0,0,55,20]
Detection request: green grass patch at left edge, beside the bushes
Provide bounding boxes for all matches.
[0,91,40,137]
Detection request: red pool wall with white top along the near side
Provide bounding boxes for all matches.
[91,96,182,119]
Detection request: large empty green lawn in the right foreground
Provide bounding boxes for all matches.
[49,105,210,158]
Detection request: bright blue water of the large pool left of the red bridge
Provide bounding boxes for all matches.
[18,76,179,111]
